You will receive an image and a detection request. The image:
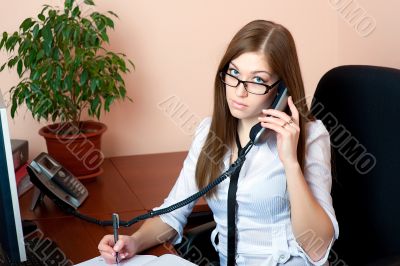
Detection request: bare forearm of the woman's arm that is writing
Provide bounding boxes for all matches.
[132,216,177,253]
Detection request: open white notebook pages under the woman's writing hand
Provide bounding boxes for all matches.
[76,254,196,266]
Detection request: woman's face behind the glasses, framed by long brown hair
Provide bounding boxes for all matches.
[225,52,278,123]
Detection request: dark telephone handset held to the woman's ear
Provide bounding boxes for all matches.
[250,81,289,145]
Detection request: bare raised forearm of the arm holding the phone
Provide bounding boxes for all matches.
[285,164,334,261]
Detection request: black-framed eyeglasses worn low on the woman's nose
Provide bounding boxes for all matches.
[219,72,280,95]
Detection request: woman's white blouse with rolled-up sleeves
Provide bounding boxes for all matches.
[155,117,339,266]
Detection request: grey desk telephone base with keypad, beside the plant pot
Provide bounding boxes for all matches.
[27,152,89,209]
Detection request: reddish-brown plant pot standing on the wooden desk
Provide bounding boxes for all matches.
[39,121,107,181]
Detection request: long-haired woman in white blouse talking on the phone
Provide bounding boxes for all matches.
[99,20,338,265]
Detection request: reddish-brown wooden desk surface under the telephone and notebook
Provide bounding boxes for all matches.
[20,152,209,263]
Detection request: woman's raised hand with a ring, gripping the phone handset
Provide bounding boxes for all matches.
[258,96,300,166]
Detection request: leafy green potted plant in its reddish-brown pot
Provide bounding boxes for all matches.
[0,0,134,182]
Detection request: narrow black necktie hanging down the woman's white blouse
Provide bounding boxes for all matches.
[227,133,243,266]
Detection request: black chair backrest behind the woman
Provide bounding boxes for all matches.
[311,65,400,265]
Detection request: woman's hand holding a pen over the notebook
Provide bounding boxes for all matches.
[98,235,138,264]
